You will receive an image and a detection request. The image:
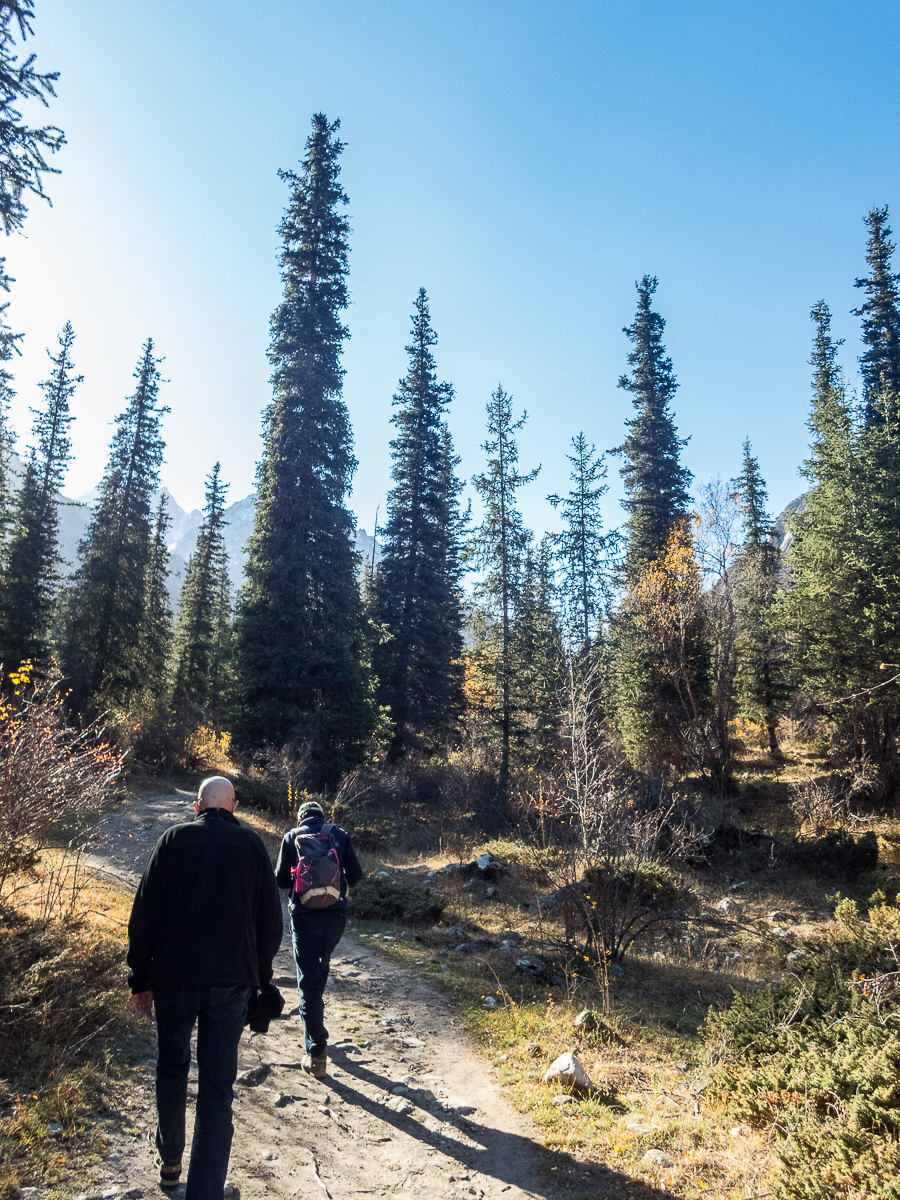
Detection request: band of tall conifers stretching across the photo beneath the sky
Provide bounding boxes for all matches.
[0,108,900,822]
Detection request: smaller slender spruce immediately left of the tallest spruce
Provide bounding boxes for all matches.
[172,463,232,715]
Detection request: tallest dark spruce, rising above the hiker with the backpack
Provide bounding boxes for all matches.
[233,113,373,786]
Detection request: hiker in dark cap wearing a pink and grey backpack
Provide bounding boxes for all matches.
[275,800,362,1079]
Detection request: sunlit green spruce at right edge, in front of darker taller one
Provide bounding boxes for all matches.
[781,304,900,770]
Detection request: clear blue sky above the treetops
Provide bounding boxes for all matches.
[5,0,900,532]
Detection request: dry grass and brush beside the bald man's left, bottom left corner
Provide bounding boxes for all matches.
[0,850,149,1200]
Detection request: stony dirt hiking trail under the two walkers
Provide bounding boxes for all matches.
[80,792,667,1200]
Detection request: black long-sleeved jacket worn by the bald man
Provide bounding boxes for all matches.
[128,809,283,992]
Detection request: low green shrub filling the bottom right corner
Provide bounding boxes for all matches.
[704,901,900,1200]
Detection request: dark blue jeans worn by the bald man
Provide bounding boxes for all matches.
[154,988,252,1200]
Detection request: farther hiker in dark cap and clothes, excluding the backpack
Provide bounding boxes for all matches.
[275,800,362,1079]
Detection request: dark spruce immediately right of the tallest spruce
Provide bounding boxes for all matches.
[372,288,462,762]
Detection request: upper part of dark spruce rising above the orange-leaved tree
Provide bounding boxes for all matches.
[612,275,692,578]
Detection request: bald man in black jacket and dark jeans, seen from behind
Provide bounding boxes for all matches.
[128,776,283,1200]
